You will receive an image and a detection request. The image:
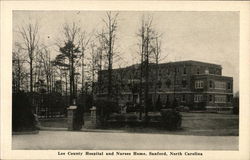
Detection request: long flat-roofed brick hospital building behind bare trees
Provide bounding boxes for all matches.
[98,60,233,110]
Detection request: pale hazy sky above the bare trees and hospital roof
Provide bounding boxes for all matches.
[13,11,239,92]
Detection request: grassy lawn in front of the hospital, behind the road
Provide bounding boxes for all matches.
[40,112,239,136]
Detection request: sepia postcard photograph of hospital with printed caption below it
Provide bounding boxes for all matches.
[1,1,249,159]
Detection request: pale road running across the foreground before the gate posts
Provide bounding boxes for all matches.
[12,131,239,150]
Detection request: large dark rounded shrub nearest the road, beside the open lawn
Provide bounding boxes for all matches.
[161,109,182,130]
